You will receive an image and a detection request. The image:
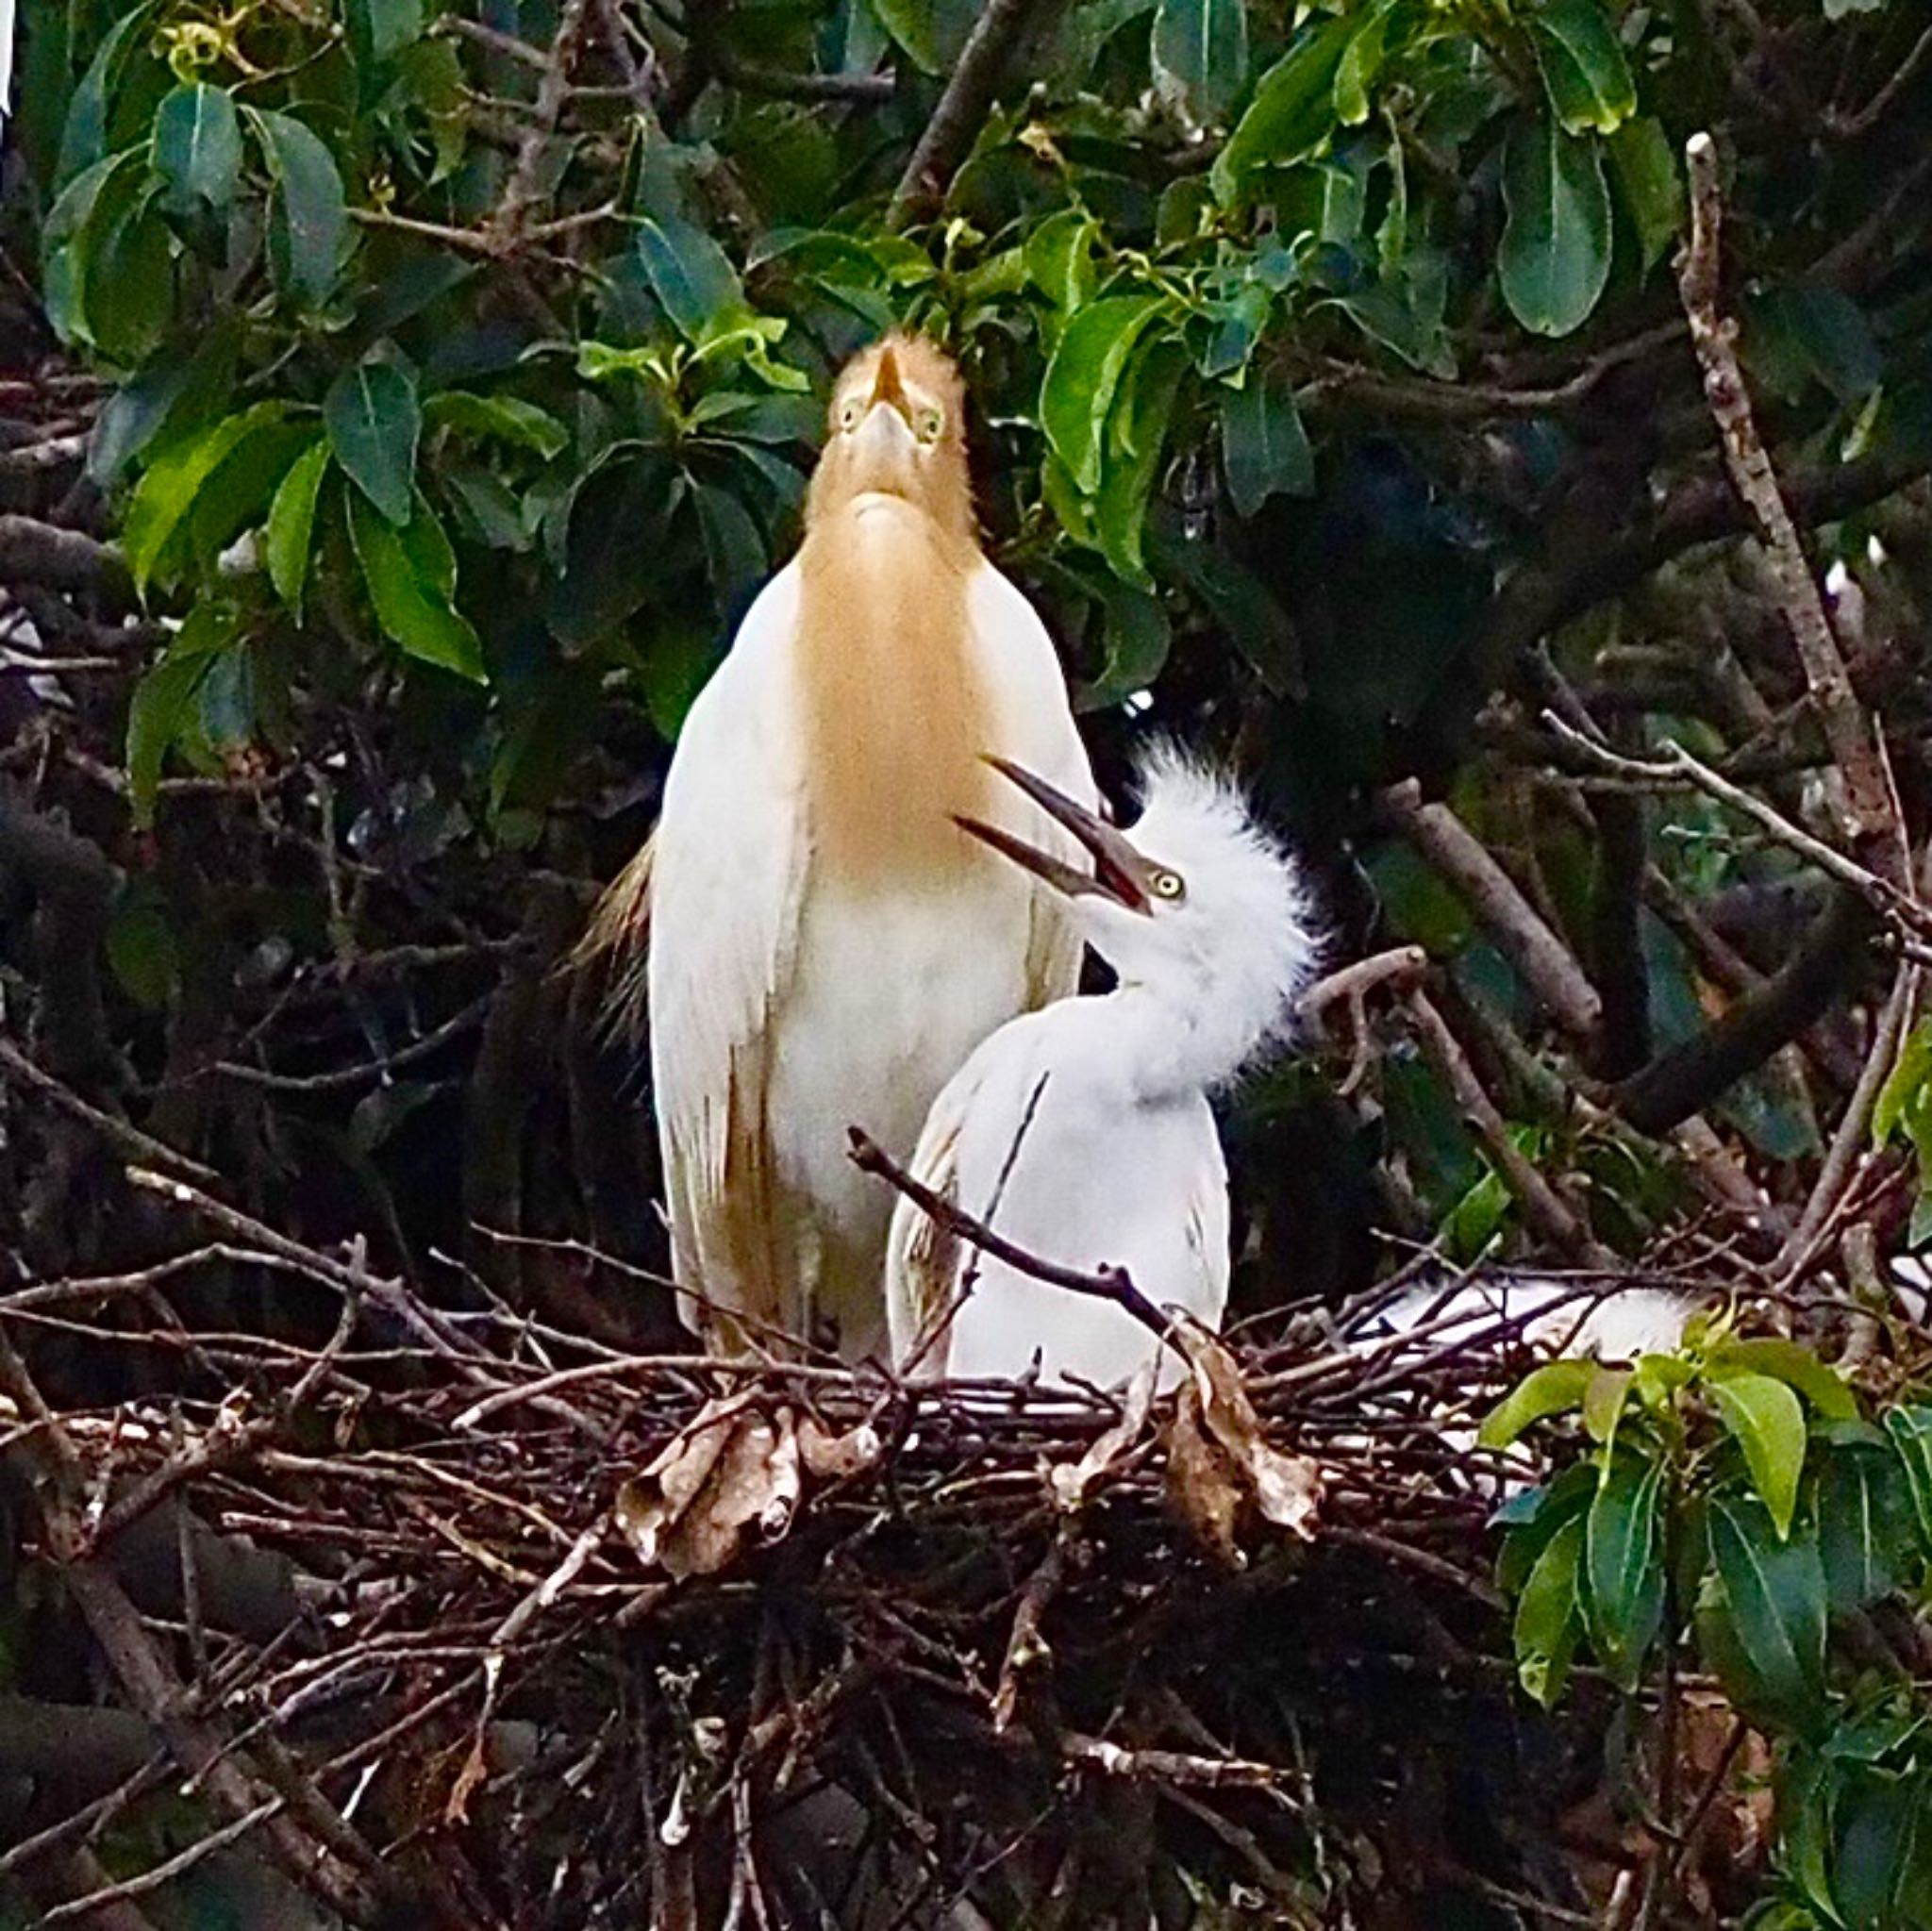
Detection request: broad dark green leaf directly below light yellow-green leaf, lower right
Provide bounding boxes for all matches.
[1709,1494,1825,1726]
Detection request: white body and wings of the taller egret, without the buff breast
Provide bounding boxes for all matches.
[647,494,1093,1359]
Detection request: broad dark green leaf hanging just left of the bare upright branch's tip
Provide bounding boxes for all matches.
[1497,114,1611,336]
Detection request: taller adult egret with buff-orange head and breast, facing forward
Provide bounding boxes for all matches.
[593,334,1095,1359]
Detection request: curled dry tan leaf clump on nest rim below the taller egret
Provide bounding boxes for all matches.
[616,1396,883,1579]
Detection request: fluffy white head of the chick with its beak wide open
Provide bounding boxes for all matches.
[968,743,1322,1083]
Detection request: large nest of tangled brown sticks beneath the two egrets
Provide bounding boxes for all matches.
[0,1174,1731,1931]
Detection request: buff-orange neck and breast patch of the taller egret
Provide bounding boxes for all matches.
[794,492,999,891]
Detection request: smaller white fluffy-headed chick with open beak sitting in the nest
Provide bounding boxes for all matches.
[887,749,1316,1385]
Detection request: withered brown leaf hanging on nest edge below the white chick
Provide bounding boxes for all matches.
[1167,1326,1322,1566]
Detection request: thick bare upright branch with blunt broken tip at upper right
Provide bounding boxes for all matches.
[1677,133,1908,887]
